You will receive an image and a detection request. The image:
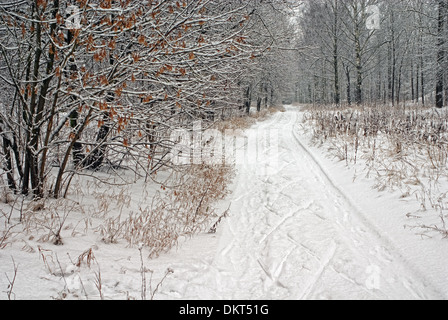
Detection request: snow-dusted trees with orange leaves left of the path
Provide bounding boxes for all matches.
[0,0,300,198]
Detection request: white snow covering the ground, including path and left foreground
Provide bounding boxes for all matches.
[0,107,448,300]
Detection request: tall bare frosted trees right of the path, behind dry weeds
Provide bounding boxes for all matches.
[295,0,448,108]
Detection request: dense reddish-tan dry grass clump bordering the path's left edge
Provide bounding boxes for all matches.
[109,165,233,257]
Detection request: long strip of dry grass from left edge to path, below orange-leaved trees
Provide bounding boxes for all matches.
[9,164,234,257]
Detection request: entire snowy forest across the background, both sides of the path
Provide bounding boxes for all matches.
[0,0,448,198]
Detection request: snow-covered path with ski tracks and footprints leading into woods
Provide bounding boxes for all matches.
[161,108,446,299]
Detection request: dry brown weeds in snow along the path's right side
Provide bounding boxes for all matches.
[304,106,448,236]
